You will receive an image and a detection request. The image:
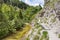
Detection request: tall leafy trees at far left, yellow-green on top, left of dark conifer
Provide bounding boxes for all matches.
[0,4,19,38]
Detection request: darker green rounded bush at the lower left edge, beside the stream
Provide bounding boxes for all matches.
[0,22,9,38]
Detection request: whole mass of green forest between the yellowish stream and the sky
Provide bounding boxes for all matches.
[0,0,42,38]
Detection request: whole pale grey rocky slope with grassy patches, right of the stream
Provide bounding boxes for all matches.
[25,0,60,40]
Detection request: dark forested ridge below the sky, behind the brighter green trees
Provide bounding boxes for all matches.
[0,0,29,9]
